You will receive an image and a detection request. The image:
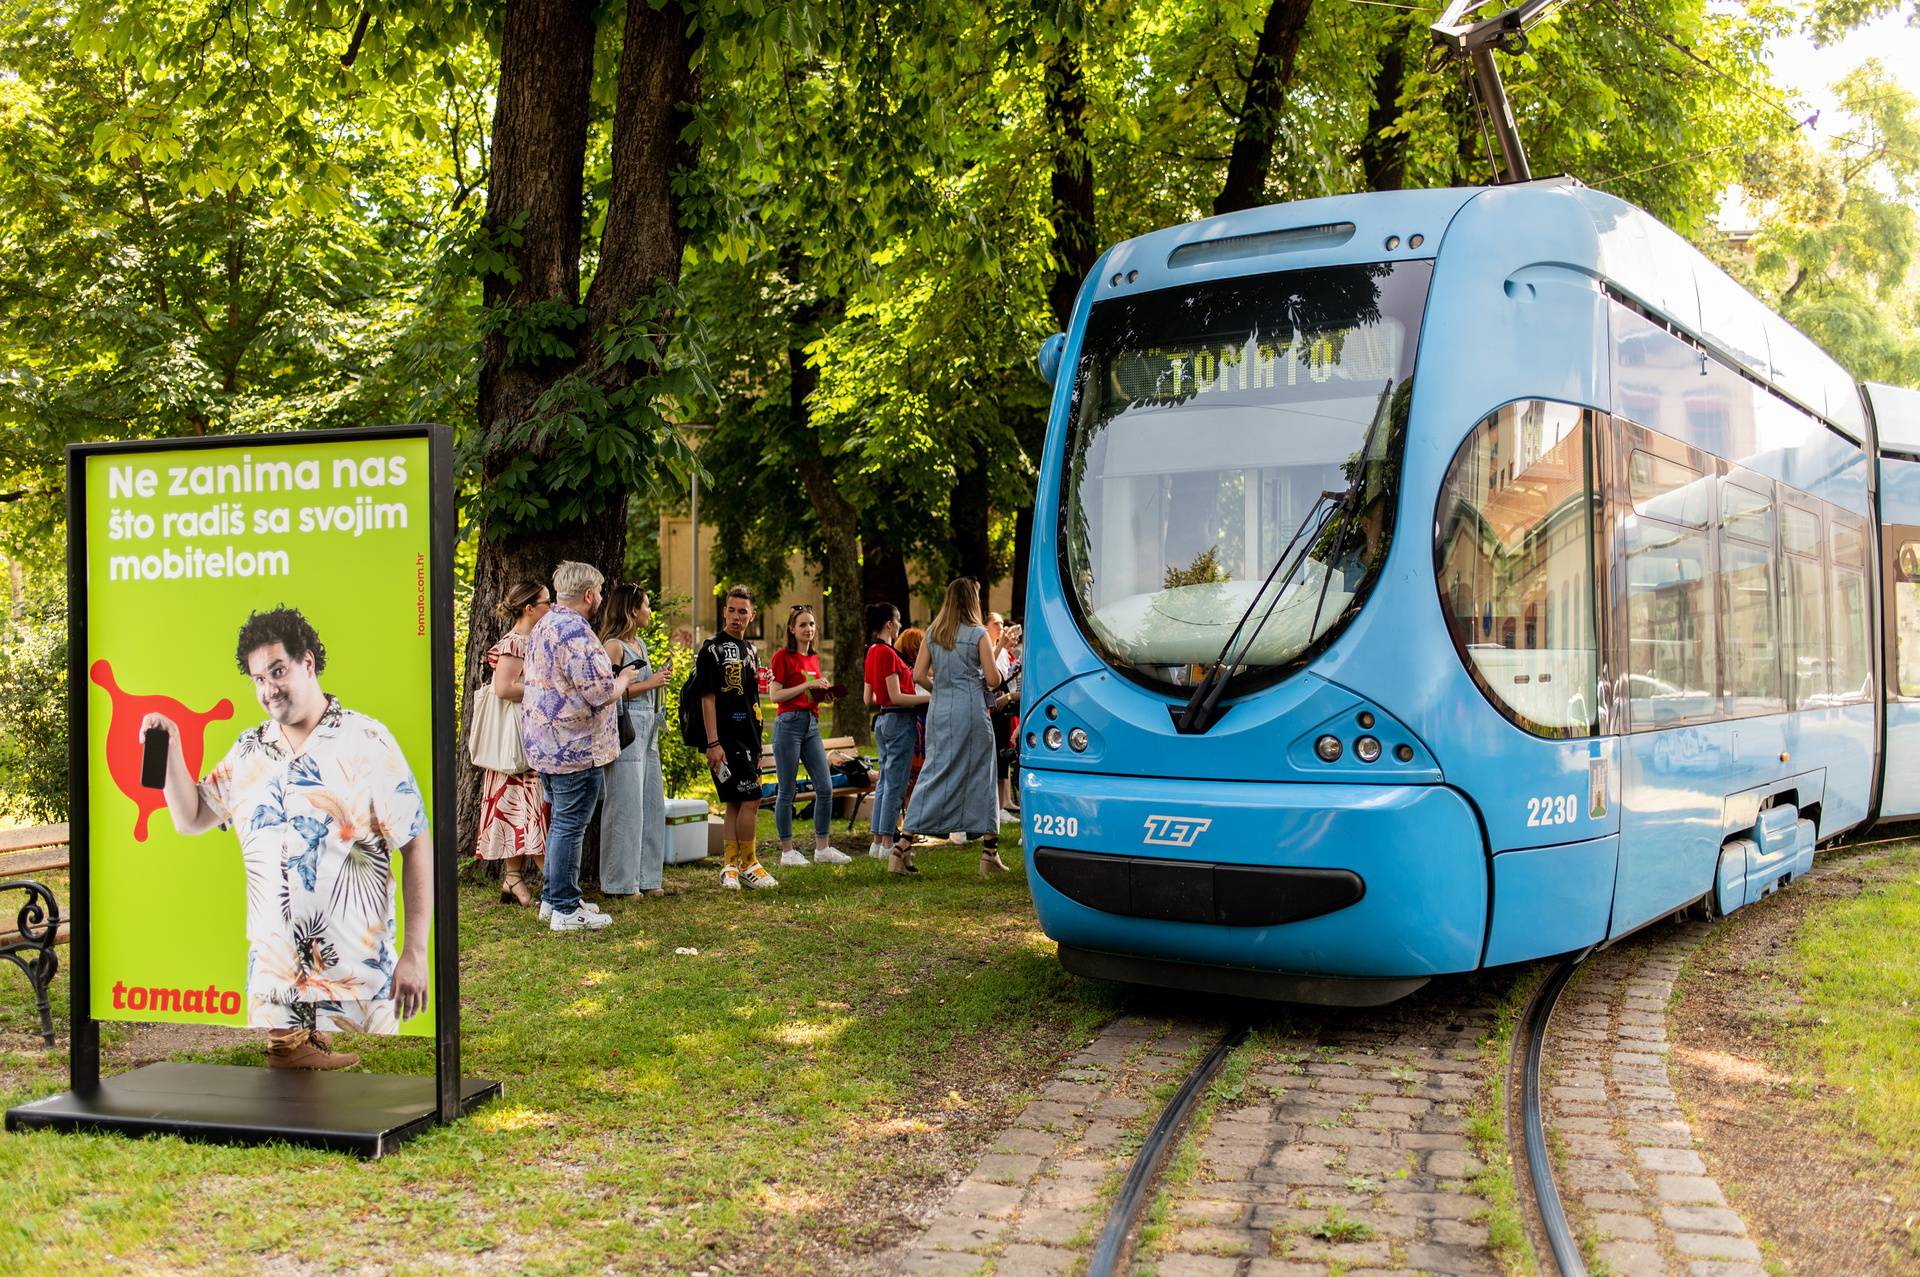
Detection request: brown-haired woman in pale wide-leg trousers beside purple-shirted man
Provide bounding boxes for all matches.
[597,586,670,895]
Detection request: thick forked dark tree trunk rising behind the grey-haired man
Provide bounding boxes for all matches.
[459,0,699,878]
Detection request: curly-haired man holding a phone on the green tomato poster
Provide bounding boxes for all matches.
[140,607,432,1070]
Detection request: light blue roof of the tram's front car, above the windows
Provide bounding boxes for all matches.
[1092,179,1866,442]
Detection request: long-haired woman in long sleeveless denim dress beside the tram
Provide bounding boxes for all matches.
[906,576,1006,876]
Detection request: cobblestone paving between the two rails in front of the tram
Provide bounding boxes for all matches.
[1152,976,1511,1277]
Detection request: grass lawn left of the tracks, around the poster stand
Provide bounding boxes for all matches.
[0,814,1116,1271]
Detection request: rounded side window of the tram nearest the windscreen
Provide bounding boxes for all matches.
[1434,399,1599,737]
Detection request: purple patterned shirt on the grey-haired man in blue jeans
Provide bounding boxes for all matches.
[520,603,620,776]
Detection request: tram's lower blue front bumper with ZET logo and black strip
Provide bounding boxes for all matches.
[1021,768,1488,987]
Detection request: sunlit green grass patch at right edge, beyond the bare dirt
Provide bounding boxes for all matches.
[1791,847,1920,1196]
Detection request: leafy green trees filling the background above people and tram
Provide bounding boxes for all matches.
[0,0,1920,810]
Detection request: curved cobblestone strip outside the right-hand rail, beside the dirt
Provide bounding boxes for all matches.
[1544,922,1766,1277]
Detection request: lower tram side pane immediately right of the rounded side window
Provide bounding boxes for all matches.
[1626,517,1718,732]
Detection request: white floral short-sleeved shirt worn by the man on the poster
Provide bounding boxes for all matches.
[200,697,428,1024]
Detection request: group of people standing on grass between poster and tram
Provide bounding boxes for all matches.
[476,563,1020,931]
